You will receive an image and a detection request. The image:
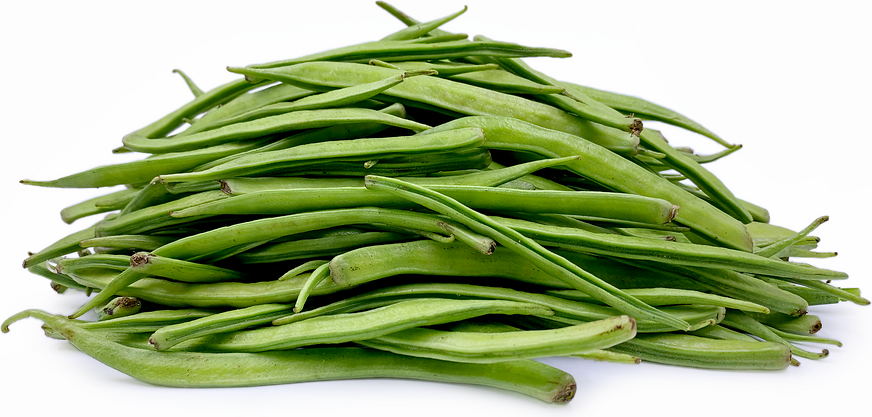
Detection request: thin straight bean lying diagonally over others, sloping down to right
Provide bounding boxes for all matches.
[365,175,689,329]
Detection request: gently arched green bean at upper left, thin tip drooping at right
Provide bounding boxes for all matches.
[124,106,429,153]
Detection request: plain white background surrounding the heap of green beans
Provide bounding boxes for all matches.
[0,0,872,416]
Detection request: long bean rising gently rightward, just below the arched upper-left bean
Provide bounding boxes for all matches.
[157,127,484,182]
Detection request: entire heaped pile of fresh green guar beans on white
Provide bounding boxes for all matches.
[2,2,869,402]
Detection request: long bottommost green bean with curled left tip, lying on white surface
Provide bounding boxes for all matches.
[2,310,575,402]
